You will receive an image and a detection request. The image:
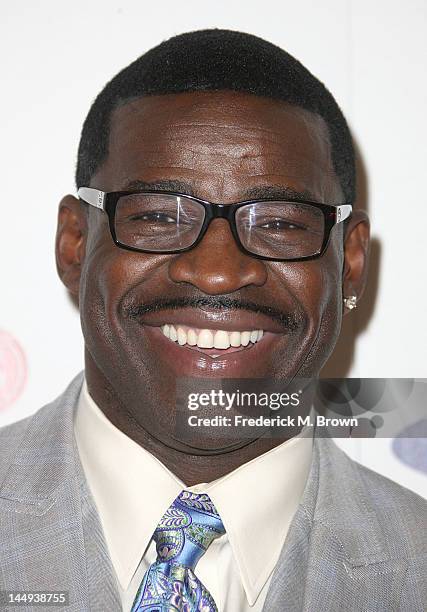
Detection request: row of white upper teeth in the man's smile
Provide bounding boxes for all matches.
[161,324,264,350]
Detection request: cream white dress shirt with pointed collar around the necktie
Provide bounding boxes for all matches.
[74,383,313,612]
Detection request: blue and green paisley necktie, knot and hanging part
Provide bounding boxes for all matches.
[131,490,225,612]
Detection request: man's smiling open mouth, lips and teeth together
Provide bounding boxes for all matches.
[129,307,292,378]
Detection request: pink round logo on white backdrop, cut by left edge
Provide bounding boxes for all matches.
[0,330,27,410]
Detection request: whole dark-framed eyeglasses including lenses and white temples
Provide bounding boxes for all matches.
[77,187,352,261]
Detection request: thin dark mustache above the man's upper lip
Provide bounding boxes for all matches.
[124,296,305,331]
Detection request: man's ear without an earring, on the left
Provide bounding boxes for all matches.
[55,195,87,298]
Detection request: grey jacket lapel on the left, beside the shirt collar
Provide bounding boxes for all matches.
[0,374,120,612]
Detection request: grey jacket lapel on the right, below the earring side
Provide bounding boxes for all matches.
[263,439,407,612]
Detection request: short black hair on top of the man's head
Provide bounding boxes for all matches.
[76,29,355,202]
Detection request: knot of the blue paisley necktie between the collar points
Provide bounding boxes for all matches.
[153,491,225,570]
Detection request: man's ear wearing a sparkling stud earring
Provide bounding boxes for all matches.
[343,210,370,313]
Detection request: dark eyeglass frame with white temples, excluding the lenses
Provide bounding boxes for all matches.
[77,187,353,261]
